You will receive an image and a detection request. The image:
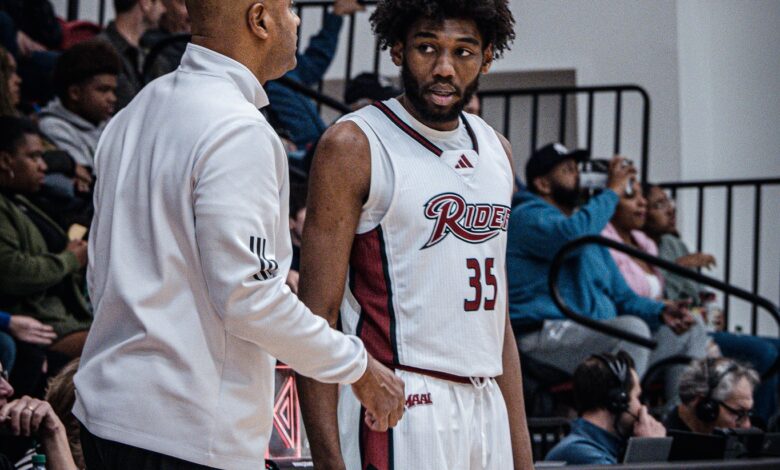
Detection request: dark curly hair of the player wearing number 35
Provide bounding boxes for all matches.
[371,0,515,58]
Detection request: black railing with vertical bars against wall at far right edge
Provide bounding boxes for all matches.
[658,178,780,335]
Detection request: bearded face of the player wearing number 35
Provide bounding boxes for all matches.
[392,19,492,123]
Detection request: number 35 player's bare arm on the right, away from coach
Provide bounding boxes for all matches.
[496,132,533,470]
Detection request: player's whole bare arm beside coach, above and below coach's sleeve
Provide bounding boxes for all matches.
[298,121,371,469]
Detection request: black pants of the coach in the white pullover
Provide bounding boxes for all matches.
[81,425,218,470]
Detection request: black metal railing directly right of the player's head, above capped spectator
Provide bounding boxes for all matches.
[477,84,650,180]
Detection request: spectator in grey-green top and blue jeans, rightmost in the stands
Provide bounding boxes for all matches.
[640,185,780,420]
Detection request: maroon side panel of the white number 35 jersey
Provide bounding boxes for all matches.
[349,227,398,364]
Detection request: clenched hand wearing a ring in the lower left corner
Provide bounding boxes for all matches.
[0,396,65,439]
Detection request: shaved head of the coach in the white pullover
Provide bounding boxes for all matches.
[186,0,300,83]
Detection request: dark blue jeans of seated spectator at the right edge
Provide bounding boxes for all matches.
[711,332,780,422]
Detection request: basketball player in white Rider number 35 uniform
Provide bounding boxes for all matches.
[300,0,532,470]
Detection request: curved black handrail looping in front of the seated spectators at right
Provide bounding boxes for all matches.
[548,235,780,350]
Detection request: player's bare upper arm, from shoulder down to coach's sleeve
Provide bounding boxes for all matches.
[299,121,371,324]
